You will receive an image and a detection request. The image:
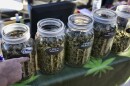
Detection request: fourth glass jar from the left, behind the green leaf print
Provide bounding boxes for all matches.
[92,8,117,58]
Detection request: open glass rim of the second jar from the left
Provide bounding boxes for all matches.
[37,18,65,37]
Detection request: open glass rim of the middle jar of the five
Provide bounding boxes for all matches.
[68,14,93,31]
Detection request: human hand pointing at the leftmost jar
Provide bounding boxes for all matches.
[0,57,29,86]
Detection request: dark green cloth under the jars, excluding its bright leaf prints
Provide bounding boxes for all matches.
[27,50,130,86]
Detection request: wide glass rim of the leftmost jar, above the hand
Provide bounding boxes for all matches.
[1,23,30,44]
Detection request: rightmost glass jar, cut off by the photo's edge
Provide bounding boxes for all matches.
[112,5,130,53]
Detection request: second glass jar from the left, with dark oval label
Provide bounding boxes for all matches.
[36,18,65,74]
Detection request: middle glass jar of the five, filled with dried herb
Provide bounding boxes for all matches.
[65,14,94,67]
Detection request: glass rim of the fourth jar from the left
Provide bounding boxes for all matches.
[93,8,117,24]
